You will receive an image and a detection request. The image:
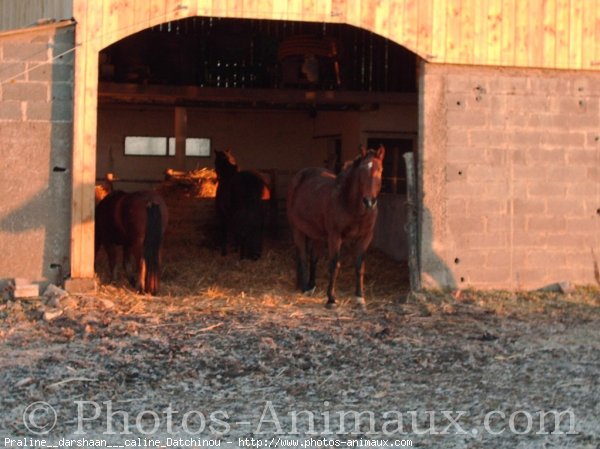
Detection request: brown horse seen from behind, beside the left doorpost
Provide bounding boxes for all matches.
[95,190,169,295]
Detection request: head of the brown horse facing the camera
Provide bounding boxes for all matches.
[354,145,385,210]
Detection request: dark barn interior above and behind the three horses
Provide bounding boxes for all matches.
[96,17,418,292]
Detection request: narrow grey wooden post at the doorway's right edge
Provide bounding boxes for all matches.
[404,152,421,292]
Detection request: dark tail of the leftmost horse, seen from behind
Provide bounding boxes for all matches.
[144,201,163,295]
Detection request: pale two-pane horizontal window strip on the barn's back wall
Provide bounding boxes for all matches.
[125,136,210,157]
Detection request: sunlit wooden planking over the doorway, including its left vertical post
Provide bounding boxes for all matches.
[69,0,600,278]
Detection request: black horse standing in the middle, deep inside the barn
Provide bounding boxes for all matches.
[215,150,271,260]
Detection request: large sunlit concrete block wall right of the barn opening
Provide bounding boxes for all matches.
[420,64,600,290]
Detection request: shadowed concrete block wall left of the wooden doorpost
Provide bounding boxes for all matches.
[0,24,74,283]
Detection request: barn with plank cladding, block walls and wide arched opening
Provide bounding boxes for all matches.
[0,0,600,291]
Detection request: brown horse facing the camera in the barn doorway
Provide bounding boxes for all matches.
[287,146,385,309]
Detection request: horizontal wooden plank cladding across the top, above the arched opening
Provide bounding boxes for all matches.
[71,0,600,70]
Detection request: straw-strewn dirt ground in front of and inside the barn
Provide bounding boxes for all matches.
[0,233,600,449]
